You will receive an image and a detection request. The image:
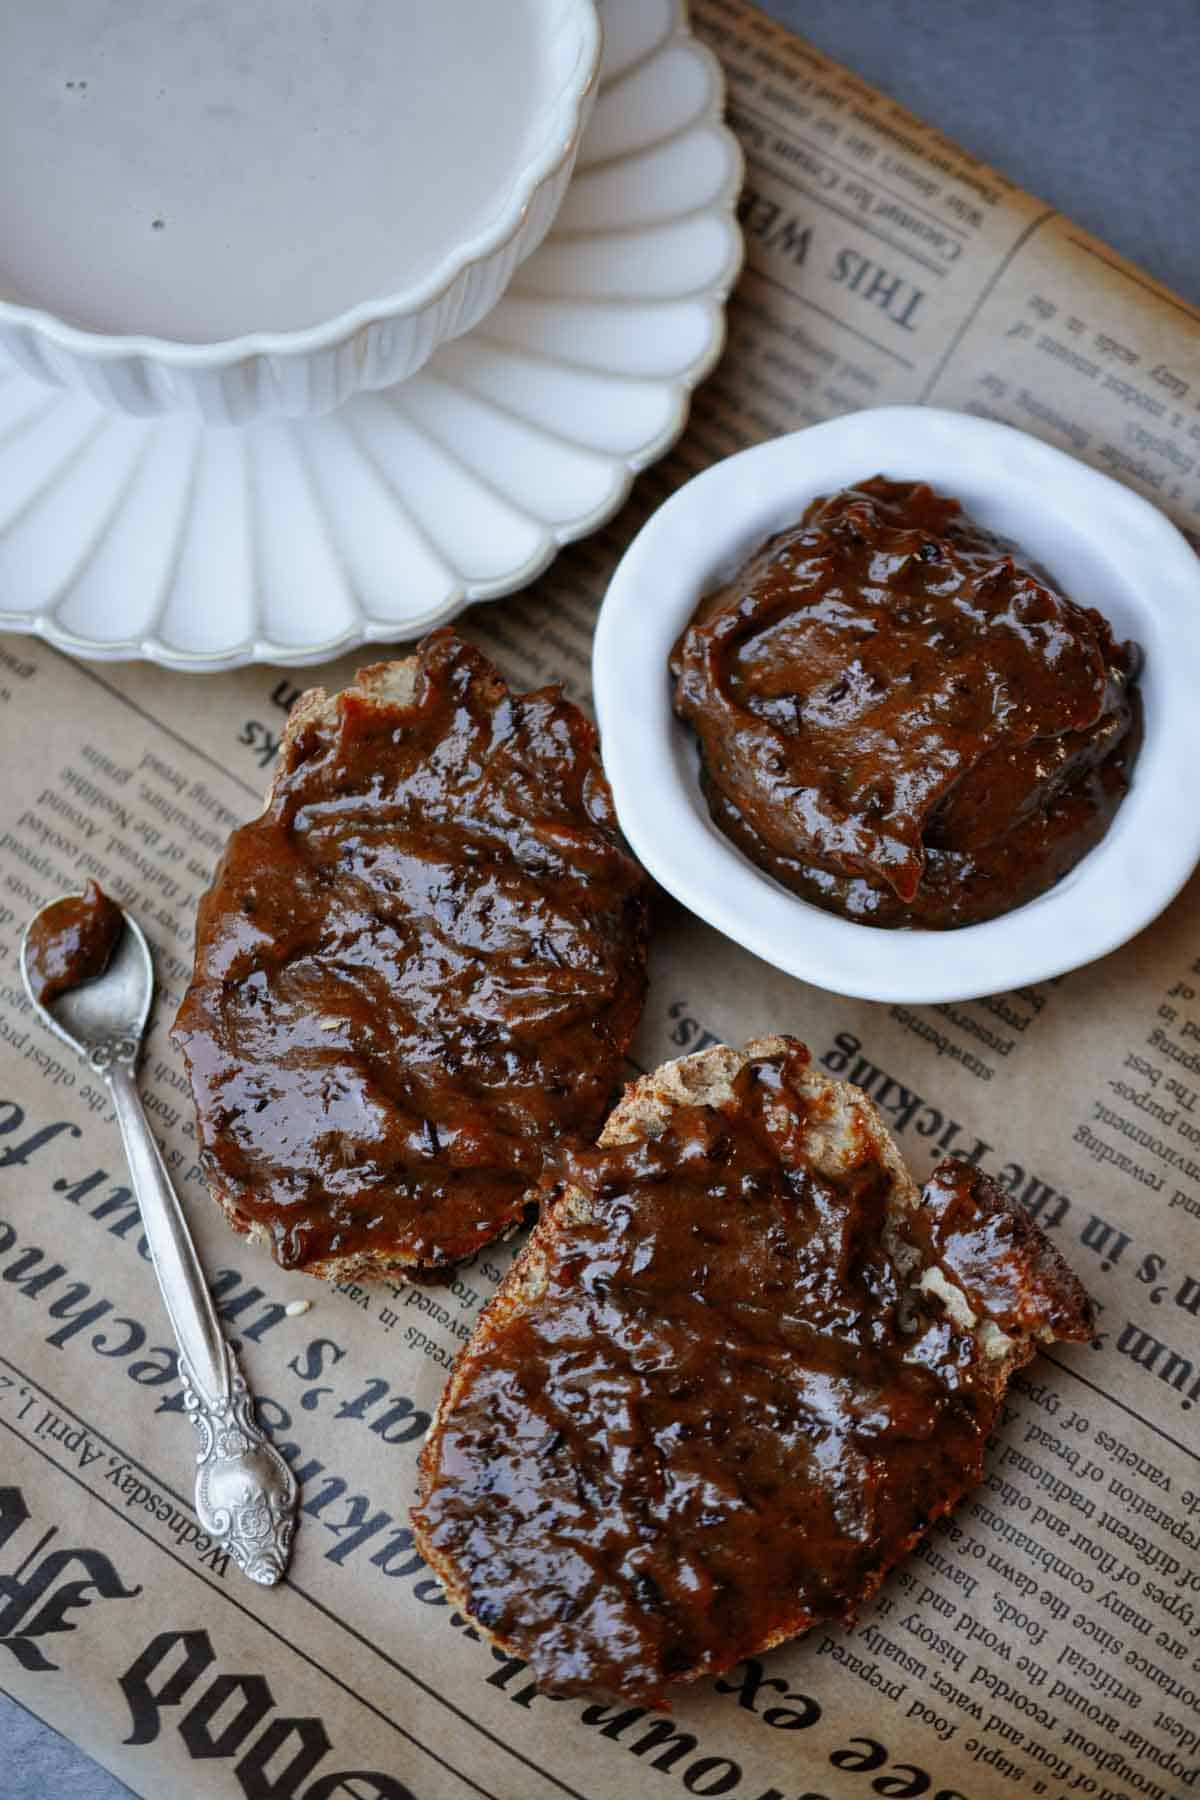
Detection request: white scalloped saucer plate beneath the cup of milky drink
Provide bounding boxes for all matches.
[0,0,741,670]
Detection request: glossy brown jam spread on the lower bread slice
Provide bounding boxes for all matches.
[414,1046,1090,1705]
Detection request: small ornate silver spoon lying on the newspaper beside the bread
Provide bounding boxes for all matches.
[22,902,297,1586]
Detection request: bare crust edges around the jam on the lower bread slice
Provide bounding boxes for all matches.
[412,1035,1094,1683]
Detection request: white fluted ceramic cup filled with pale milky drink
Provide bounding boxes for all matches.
[0,0,601,425]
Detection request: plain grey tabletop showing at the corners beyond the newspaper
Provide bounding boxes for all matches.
[0,0,1200,1800]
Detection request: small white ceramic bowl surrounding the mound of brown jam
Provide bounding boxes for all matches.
[594,407,1200,1004]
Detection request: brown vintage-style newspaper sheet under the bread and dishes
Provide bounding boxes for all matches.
[0,0,1200,1800]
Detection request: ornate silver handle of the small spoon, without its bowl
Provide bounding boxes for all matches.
[103,1044,297,1586]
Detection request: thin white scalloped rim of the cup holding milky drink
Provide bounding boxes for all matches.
[0,0,604,371]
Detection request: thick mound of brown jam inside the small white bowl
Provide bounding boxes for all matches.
[671,475,1141,929]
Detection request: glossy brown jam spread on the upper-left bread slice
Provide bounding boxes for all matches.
[176,630,646,1273]
